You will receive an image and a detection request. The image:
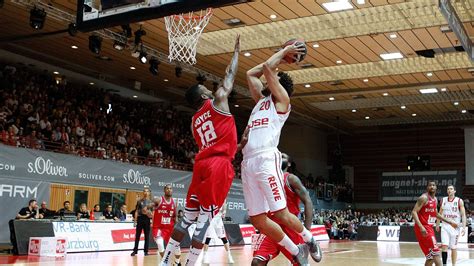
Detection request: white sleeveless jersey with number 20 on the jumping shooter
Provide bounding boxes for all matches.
[242,95,291,159]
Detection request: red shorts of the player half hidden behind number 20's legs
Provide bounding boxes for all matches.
[253,222,305,265]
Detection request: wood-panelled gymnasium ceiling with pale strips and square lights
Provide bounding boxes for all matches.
[0,0,474,132]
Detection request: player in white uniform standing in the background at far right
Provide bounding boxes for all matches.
[436,185,466,265]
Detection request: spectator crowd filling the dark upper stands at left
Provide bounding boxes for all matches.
[0,65,197,170]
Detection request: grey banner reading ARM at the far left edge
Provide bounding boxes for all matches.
[0,178,50,243]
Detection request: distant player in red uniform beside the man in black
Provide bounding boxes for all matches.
[151,184,176,257]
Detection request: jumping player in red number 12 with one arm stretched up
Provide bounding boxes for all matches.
[161,35,240,265]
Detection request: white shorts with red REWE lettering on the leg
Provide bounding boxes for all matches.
[242,149,286,216]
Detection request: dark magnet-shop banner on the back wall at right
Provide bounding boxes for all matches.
[379,170,462,201]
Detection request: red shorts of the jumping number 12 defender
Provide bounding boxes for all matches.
[186,156,235,215]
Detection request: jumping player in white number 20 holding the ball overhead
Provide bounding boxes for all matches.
[242,44,321,264]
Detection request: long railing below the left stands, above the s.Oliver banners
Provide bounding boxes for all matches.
[0,136,193,171]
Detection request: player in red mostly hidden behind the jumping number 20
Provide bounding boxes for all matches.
[252,153,322,266]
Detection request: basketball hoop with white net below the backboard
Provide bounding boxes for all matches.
[165,8,212,65]
